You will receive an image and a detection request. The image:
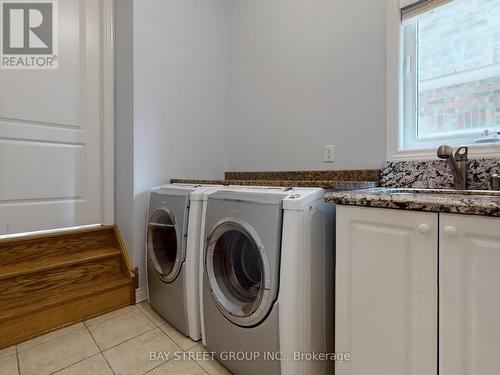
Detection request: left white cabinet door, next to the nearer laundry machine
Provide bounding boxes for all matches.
[335,206,438,375]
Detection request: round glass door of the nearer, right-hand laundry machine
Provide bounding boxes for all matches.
[205,218,273,326]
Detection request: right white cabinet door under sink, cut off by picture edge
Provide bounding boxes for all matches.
[439,215,500,375]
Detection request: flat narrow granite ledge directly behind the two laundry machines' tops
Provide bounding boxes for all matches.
[170,179,378,191]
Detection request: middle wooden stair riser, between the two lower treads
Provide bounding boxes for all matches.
[0,256,121,311]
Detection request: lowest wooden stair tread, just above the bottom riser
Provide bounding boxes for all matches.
[0,274,131,323]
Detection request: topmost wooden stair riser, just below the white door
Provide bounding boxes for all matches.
[0,230,114,265]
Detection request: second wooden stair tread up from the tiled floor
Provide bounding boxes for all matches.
[0,247,121,280]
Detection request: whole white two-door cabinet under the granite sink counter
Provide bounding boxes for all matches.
[335,206,500,375]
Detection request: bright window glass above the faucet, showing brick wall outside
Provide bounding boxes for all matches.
[418,0,500,136]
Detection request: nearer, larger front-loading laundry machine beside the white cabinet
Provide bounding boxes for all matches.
[200,187,335,375]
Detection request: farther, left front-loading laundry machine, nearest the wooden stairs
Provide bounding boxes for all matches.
[146,184,218,341]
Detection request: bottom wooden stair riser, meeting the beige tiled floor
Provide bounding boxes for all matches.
[0,287,130,349]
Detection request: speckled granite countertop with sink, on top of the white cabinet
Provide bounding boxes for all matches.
[325,188,500,217]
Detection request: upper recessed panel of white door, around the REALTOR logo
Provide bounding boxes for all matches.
[0,0,80,127]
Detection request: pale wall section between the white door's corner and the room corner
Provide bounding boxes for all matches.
[133,0,228,285]
